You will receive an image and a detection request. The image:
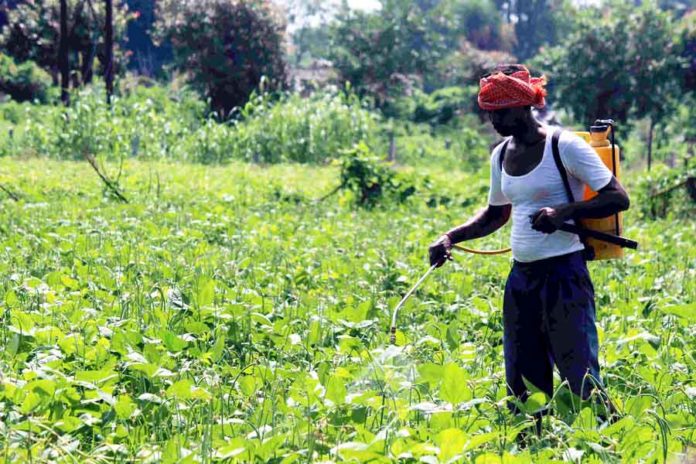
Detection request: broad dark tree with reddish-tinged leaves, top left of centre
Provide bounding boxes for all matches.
[155,0,287,115]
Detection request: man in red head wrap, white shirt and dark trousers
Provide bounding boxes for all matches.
[429,65,629,420]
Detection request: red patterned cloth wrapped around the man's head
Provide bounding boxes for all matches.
[478,65,546,111]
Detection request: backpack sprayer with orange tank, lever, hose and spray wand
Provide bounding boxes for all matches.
[389,119,638,345]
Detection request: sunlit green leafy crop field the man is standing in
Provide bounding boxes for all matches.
[0,157,696,463]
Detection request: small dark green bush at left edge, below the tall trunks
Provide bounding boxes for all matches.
[0,53,51,103]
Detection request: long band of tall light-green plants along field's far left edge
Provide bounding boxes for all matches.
[0,87,377,163]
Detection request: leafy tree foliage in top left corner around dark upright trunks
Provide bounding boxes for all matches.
[0,0,132,85]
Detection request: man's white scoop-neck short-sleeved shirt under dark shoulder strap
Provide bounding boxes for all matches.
[488,126,612,263]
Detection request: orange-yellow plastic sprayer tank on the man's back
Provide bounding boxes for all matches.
[576,122,624,260]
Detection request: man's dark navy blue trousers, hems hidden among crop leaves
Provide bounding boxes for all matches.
[503,252,602,400]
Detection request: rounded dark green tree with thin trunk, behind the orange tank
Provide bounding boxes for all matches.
[533,2,683,169]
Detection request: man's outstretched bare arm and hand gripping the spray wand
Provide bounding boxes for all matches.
[429,204,512,267]
